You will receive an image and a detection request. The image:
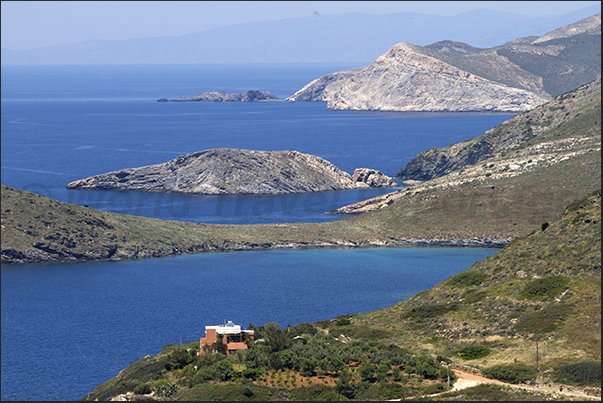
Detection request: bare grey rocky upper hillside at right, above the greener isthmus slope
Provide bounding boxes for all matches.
[334,78,601,214]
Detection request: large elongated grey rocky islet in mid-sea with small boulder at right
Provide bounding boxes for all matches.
[67,148,391,195]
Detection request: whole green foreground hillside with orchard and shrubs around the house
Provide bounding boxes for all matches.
[82,190,601,401]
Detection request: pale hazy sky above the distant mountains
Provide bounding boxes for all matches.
[0,1,601,50]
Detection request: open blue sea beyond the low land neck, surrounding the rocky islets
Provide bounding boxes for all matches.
[1,64,512,224]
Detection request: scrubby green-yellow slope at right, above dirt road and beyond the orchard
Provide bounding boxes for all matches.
[352,190,601,368]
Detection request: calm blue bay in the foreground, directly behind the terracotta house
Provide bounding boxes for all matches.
[0,248,496,400]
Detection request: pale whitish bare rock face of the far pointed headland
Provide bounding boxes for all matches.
[287,42,548,112]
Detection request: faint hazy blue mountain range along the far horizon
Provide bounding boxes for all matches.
[1,6,601,65]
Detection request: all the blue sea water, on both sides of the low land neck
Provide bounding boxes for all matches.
[0,63,513,400]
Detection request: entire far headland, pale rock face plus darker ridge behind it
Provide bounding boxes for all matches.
[287,14,601,112]
